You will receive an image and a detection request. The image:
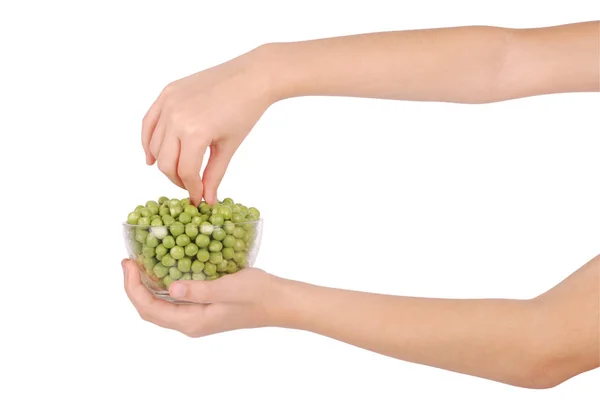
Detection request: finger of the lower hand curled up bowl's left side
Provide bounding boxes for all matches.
[123,260,178,328]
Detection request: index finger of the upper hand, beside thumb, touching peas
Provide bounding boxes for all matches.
[177,140,208,206]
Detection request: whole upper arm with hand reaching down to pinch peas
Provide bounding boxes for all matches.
[142,21,600,205]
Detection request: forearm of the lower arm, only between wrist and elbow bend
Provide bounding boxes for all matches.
[279,281,535,386]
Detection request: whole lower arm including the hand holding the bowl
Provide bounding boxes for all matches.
[123,256,600,388]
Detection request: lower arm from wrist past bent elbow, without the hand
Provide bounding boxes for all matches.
[275,253,600,388]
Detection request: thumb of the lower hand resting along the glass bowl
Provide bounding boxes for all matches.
[169,271,247,304]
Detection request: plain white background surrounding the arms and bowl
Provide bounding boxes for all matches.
[0,0,600,401]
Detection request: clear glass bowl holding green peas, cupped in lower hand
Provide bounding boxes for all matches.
[123,219,263,303]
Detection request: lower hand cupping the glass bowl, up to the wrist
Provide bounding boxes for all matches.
[122,259,279,337]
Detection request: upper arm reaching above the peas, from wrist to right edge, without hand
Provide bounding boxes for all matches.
[263,22,600,103]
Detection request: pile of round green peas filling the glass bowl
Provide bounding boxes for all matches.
[126,196,260,289]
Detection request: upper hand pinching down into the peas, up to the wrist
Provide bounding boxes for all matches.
[142,48,274,206]
